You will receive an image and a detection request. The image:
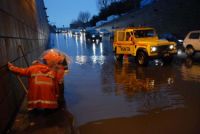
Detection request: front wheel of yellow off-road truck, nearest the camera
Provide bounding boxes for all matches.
[136,51,148,66]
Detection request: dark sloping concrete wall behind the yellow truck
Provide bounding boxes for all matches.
[99,0,200,37]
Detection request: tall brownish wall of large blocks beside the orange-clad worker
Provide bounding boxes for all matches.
[0,0,49,133]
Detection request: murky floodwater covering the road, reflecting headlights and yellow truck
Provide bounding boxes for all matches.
[51,34,200,134]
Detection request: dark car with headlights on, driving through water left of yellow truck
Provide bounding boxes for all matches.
[85,29,102,42]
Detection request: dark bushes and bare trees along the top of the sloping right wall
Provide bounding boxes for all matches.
[70,0,141,28]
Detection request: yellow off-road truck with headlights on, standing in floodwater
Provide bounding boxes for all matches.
[113,27,177,65]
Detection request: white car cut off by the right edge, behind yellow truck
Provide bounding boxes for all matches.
[183,30,200,56]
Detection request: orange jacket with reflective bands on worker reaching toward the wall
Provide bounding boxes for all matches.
[9,64,62,109]
